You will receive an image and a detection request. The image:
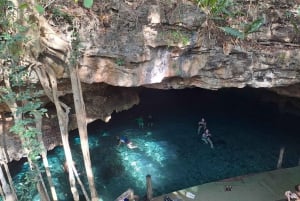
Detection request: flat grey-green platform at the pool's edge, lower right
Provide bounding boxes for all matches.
[152,166,300,201]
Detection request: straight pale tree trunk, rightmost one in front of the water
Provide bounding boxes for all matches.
[69,64,99,201]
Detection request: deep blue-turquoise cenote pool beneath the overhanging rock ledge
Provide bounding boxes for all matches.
[14,88,300,201]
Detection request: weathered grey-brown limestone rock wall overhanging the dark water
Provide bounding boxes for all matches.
[64,1,300,89]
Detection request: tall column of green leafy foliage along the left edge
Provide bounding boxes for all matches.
[0,0,53,200]
